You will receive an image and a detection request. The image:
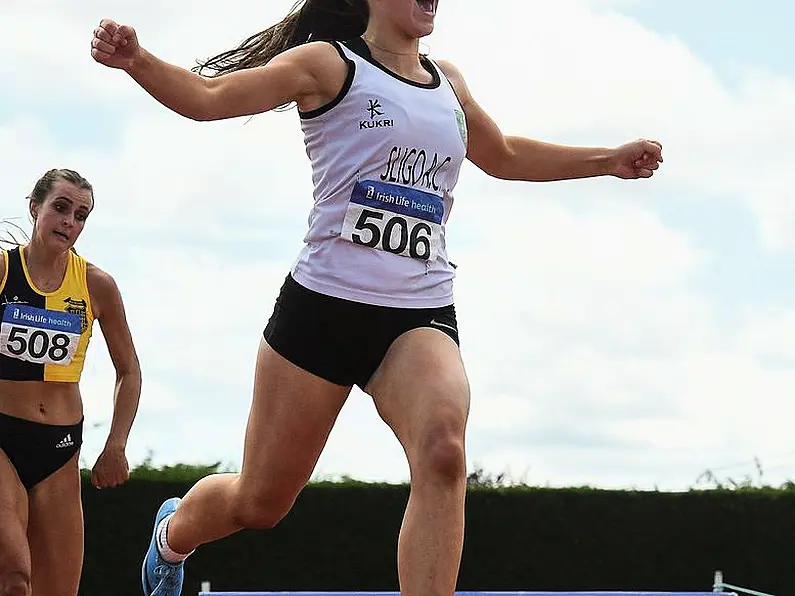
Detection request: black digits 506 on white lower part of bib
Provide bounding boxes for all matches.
[351,209,431,259]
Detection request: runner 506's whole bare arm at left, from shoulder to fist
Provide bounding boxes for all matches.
[91,19,347,120]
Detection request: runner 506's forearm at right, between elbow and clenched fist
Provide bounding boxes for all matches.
[499,137,614,182]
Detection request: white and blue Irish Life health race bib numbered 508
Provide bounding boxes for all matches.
[0,304,81,365]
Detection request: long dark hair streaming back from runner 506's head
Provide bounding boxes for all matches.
[192,0,370,77]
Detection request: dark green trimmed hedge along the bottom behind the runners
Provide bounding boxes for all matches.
[76,466,795,596]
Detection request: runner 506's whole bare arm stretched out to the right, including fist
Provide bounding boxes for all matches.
[439,61,662,182]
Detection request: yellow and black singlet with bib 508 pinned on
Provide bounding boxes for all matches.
[0,247,94,383]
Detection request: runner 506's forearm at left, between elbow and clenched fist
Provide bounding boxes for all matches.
[127,48,212,120]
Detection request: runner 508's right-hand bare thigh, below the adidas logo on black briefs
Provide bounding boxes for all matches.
[28,453,83,596]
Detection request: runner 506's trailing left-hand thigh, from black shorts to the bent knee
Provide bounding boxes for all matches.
[241,340,350,493]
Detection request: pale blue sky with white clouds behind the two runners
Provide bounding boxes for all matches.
[0,0,795,490]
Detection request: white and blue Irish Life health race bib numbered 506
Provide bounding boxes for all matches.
[341,180,444,261]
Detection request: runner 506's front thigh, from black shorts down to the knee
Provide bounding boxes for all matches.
[365,327,470,461]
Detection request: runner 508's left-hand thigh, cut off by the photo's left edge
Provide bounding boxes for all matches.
[0,451,30,592]
